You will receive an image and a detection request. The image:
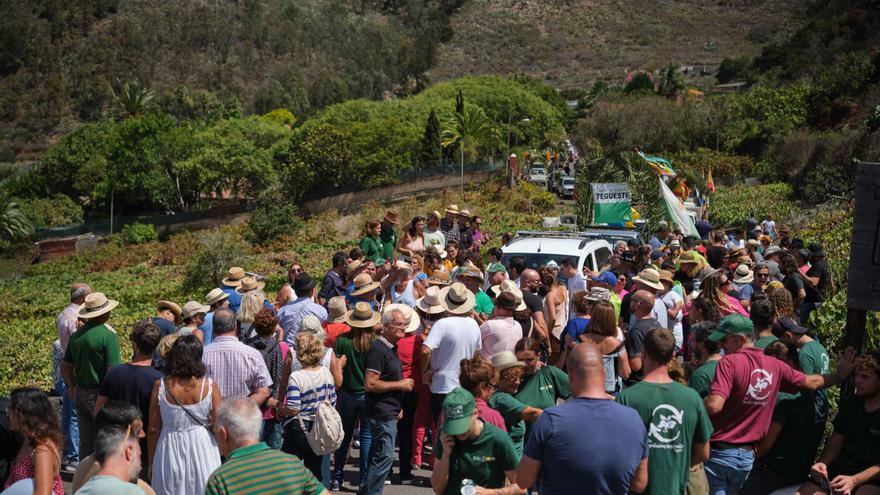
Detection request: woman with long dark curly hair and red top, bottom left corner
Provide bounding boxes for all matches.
[3,387,64,495]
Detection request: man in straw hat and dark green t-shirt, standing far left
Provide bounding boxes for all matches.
[61,292,120,459]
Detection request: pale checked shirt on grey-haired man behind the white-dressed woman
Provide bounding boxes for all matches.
[202,335,272,399]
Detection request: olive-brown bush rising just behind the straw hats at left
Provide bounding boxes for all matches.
[183,229,247,293]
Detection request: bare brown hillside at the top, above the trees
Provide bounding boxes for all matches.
[428,0,807,88]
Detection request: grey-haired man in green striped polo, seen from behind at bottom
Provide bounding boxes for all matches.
[205,398,330,495]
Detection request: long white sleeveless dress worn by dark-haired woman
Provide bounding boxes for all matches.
[150,378,220,495]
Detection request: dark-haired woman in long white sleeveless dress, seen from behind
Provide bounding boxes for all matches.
[147,335,220,495]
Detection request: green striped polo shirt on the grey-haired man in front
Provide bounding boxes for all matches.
[205,442,324,495]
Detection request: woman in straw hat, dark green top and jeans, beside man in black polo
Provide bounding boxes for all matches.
[331,305,380,491]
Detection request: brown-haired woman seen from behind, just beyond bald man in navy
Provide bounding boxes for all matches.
[578,301,632,395]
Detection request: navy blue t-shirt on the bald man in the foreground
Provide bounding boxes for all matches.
[524,399,648,495]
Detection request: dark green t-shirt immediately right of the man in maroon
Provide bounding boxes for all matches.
[763,391,824,484]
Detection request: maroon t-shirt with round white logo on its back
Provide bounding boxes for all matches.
[709,347,807,444]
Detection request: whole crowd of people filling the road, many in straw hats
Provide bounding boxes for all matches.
[3,205,880,495]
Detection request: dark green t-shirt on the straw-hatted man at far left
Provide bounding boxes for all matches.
[64,323,120,388]
